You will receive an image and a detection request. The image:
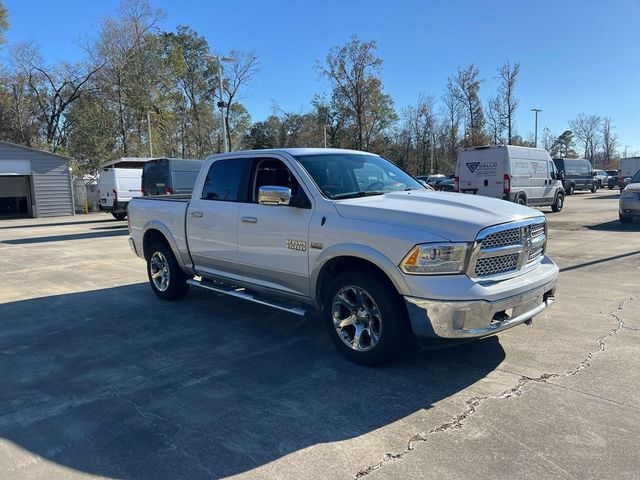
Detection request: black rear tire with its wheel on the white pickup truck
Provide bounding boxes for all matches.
[147,243,190,300]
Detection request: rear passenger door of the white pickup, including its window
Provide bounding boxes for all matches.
[186,158,251,280]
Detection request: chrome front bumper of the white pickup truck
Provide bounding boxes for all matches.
[404,278,556,339]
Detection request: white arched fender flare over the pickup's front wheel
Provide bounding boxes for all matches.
[311,243,411,306]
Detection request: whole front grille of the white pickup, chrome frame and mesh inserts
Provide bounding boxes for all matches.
[468,218,547,278]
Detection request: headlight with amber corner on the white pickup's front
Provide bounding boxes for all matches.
[400,243,469,275]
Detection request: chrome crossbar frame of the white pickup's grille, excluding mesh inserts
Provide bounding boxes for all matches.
[466,217,547,282]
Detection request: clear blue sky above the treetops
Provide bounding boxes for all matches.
[4,0,640,153]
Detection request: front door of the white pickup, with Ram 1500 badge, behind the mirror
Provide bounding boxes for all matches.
[238,158,313,297]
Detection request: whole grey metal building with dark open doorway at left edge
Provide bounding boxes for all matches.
[0,140,74,219]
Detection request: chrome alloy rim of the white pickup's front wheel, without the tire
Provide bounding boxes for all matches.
[332,285,382,352]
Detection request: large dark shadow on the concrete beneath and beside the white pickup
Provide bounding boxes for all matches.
[0,284,505,479]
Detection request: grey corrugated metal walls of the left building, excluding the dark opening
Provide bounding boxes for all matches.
[0,142,74,217]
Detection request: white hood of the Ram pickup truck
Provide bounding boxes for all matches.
[335,190,544,242]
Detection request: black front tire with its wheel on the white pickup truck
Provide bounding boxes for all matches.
[322,271,411,365]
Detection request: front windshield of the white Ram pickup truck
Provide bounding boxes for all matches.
[295,153,426,200]
